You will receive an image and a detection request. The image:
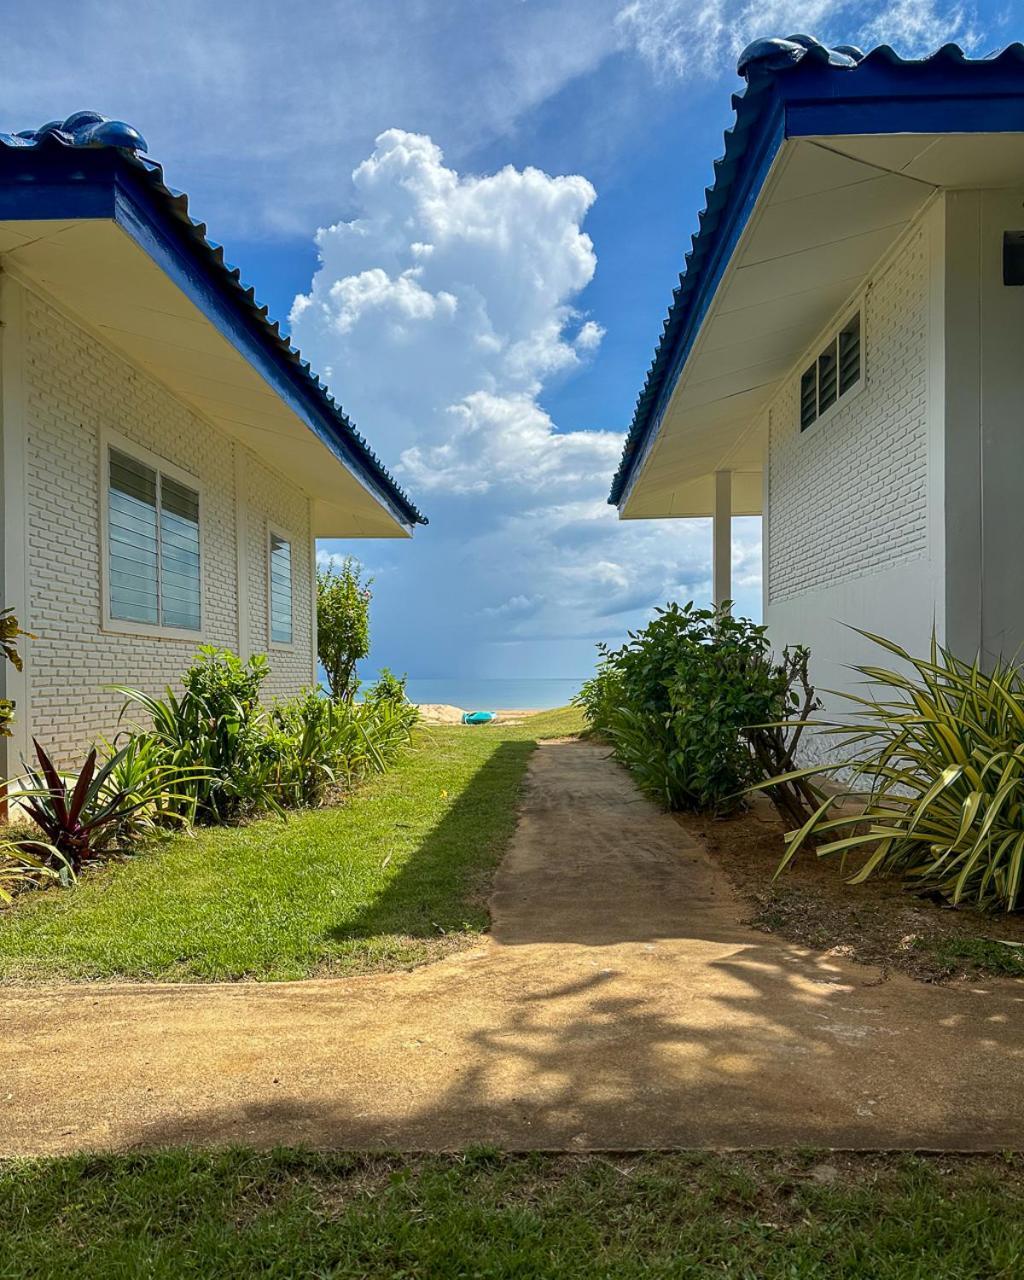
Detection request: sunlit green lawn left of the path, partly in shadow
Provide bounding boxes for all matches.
[0,710,582,982]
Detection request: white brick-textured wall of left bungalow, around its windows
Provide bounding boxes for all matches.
[23,293,311,756]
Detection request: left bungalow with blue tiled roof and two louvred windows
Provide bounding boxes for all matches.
[0,111,425,762]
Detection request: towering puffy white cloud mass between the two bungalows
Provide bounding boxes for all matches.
[292,129,758,675]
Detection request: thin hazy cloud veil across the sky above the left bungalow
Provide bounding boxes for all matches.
[0,0,618,236]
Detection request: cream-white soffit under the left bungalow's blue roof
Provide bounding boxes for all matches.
[0,219,408,538]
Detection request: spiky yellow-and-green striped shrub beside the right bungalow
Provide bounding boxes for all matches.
[762,632,1024,911]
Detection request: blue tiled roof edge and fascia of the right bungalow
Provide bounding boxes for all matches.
[608,36,1024,504]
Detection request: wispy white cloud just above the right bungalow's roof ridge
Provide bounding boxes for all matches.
[616,0,978,76]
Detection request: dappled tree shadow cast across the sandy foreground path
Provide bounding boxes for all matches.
[115,926,1024,1151]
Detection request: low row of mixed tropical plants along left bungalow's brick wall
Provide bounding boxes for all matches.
[0,648,417,901]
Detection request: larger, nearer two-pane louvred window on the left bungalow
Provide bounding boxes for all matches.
[106,445,202,631]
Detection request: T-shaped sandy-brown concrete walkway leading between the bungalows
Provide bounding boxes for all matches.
[0,742,1024,1155]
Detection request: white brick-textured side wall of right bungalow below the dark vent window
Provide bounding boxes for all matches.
[764,205,945,754]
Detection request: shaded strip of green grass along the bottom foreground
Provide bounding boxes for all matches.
[0,1151,1024,1280]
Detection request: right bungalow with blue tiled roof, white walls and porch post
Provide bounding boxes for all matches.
[611,36,1024,721]
